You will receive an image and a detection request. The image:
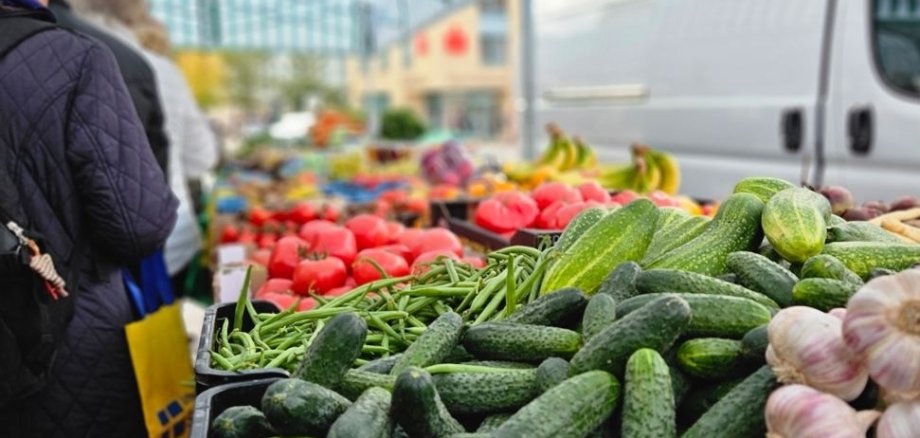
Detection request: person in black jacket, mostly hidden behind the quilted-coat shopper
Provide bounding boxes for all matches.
[49,0,169,174]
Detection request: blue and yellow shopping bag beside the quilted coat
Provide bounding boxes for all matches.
[123,251,195,438]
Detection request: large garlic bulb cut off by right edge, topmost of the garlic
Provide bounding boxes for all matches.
[843,270,920,397]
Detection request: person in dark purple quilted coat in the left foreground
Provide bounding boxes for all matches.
[0,0,178,438]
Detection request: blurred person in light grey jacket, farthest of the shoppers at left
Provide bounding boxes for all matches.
[131,16,217,295]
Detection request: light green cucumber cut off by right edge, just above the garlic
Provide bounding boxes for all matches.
[824,242,920,279]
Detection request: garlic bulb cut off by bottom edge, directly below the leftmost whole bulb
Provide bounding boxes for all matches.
[765,385,879,438]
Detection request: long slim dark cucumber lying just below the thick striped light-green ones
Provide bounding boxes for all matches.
[636,269,779,309]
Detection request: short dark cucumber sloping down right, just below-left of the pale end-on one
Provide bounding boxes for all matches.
[725,251,799,307]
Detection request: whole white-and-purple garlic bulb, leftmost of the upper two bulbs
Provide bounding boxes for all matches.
[766,306,869,401]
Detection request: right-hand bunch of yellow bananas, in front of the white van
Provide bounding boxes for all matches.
[598,145,680,195]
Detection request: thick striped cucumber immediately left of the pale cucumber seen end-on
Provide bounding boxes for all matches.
[643,193,763,275]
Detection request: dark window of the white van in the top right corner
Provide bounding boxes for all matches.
[873,0,920,97]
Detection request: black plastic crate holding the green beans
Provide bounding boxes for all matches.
[195,301,290,394]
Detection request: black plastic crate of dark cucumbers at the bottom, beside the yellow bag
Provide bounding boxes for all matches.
[191,378,278,438]
